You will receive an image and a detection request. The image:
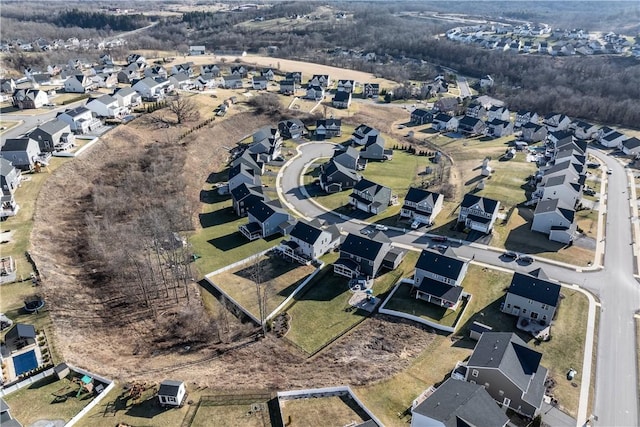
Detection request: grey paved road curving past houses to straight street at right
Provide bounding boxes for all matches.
[280,143,640,426]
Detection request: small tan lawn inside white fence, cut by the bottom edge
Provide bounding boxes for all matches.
[280,396,368,427]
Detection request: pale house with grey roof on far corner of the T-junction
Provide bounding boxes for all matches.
[531,199,576,243]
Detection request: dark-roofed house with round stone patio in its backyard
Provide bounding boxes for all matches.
[333,232,404,279]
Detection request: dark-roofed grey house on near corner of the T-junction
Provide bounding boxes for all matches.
[501,272,560,325]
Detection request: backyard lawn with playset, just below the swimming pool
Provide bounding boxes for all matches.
[4,375,91,426]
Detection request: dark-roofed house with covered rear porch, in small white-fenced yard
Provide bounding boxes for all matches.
[413,250,469,310]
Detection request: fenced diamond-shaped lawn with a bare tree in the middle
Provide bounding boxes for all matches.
[210,256,315,319]
